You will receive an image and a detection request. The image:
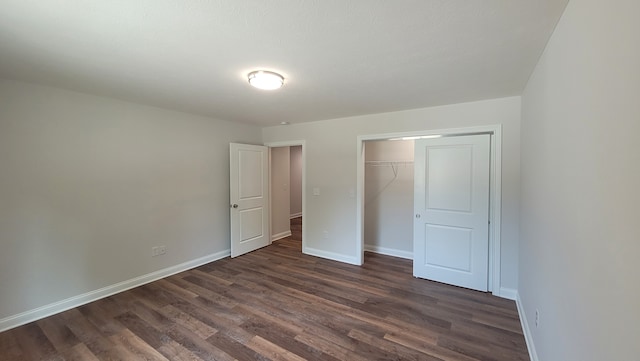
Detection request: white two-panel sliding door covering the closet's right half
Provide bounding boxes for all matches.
[413,134,490,291]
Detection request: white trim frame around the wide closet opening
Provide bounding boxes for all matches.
[358,124,502,296]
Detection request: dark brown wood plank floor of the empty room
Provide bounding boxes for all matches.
[0,217,529,361]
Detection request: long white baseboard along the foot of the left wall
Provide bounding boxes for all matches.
[0,250,231,332]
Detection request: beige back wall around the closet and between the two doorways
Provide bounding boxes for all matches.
[263,97,520,289]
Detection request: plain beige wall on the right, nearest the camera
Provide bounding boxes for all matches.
[519,0,640,361]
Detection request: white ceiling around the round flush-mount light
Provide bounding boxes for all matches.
[0,0,567,126]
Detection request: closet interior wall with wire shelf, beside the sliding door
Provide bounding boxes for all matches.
[364,140,414,259]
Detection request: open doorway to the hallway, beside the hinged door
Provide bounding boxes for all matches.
[267,142,305,250]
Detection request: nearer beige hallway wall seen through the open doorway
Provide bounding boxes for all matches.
[271,147,291,240]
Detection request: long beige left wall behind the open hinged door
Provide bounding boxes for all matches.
[0,80,261,321]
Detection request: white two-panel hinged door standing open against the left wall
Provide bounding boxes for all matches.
[229,143,269,257]
